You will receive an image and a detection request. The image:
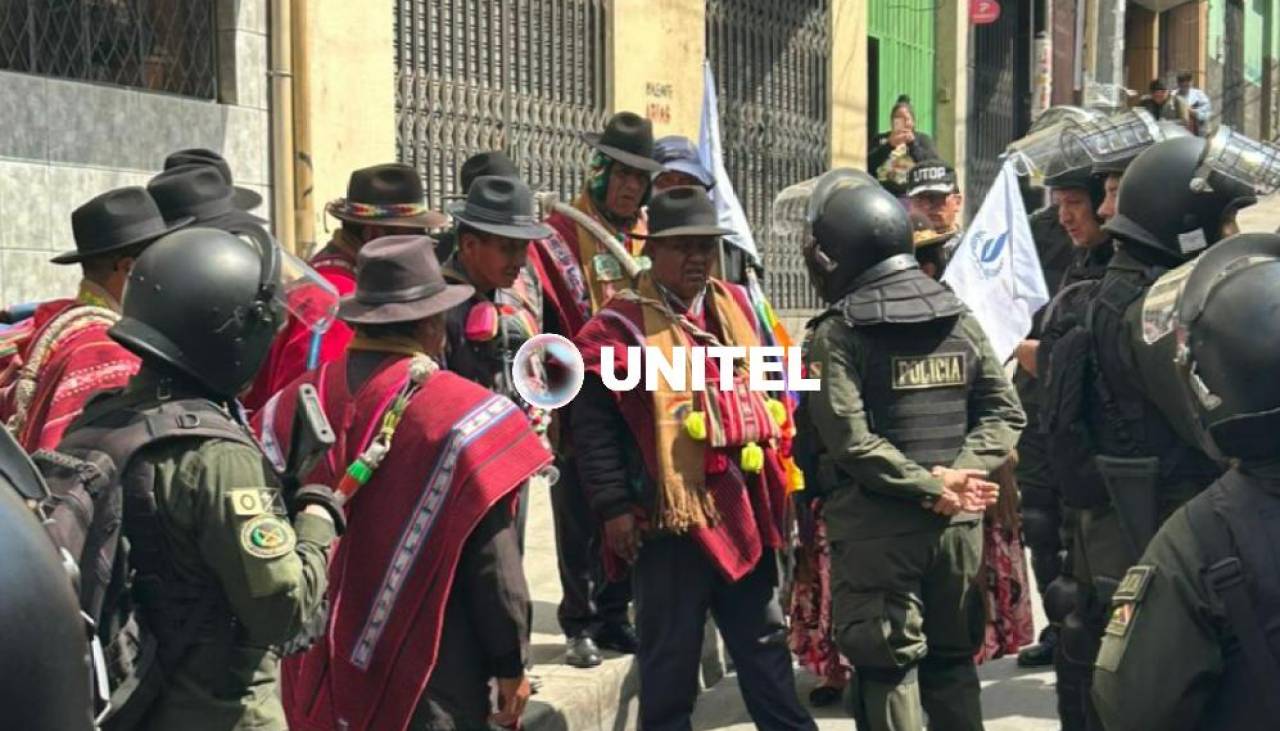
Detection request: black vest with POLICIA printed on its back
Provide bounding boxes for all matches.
[859,317,978,466]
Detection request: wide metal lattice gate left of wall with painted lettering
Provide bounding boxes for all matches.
[396,0,607,206]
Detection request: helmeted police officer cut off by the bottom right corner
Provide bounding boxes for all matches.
[1093,233,1280,731]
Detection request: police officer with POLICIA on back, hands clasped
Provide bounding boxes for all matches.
[799,172,1024,731]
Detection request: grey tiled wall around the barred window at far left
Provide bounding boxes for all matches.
[0,0,270,303]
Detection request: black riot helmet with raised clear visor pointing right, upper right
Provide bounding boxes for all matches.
[1105,137,1257,262]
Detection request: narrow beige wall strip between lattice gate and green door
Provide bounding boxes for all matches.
[831,0,867,168]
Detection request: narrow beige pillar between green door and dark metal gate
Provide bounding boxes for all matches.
[933,0,969,191]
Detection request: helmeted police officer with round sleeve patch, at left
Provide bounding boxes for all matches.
[60,228,342,731]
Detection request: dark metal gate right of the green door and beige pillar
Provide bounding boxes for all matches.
[965,0,1030,220]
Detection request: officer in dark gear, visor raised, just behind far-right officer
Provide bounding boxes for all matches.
[1039,137,1256,730]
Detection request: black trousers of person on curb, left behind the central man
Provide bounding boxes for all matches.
[552,458,631,638]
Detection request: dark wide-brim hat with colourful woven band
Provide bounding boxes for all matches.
[325,163,449,229]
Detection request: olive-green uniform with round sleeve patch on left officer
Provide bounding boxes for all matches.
[131,419,334,731]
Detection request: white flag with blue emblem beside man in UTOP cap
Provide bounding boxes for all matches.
[942,160,1048,362]
